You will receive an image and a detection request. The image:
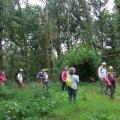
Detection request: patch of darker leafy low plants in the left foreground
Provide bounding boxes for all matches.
[0,84,57,120]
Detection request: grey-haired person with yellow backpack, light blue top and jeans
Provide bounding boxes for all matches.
[66,67,79,102]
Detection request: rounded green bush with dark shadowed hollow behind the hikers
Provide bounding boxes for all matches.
[58,47,101,81]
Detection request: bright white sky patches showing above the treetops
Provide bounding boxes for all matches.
[29,0,114,12]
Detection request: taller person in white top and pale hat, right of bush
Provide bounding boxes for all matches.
[98,62,107,94]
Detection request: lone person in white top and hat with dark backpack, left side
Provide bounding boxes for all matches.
[15,69,23,88]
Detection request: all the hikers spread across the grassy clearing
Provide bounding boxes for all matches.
[0,62,116,101]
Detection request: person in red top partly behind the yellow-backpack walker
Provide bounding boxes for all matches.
[62,66,69,90]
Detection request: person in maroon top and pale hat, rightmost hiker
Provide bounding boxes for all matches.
[105,66,116,99]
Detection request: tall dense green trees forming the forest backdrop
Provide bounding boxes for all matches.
[0,0,120,80]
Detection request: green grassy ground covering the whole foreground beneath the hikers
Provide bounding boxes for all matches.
[0,82,120,120]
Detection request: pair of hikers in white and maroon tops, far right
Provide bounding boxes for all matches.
[98,62,116,99]
